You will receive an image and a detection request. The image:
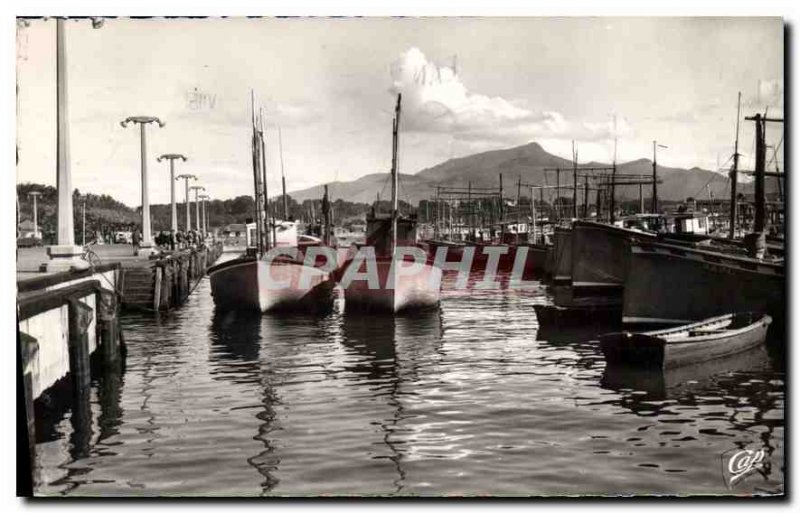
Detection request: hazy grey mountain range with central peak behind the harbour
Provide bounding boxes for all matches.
[290,142,736,205]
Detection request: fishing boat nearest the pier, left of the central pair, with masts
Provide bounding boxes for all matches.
[207,94,335,312]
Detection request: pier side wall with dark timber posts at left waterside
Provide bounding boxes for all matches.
[17,244,222,492]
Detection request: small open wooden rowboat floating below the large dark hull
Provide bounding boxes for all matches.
[600,313,772,369]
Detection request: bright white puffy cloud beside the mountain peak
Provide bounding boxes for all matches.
[390,48,631,146]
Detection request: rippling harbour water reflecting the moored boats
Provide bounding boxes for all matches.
[35,262,785,496]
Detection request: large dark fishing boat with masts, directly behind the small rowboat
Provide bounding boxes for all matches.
[623,102,786,325]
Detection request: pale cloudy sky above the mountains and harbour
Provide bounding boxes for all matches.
[17,17,784,206]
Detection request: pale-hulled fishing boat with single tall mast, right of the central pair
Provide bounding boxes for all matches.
[340,94,442,314]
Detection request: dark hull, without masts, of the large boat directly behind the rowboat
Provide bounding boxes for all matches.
[622,242,786,324]
